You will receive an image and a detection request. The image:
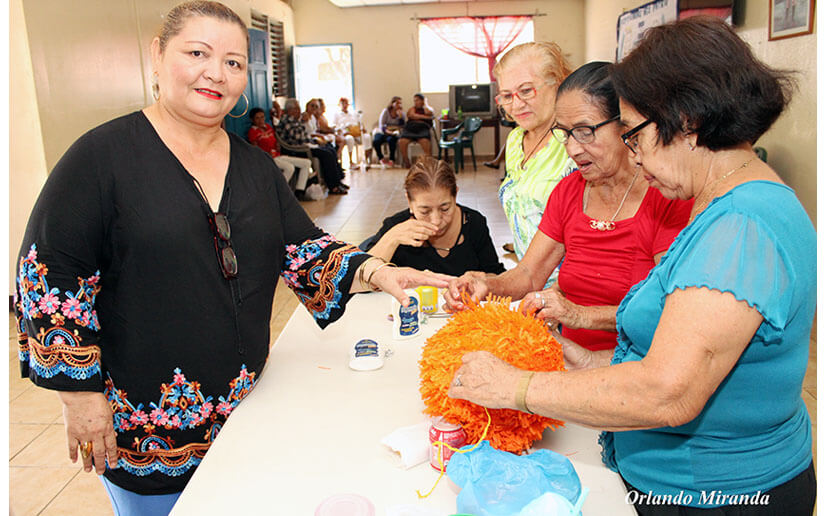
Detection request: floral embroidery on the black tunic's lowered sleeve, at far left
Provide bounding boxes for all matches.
[16,244,100,380]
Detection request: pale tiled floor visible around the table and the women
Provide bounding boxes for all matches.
[9,164,816,516]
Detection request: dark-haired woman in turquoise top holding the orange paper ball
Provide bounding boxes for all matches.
[450,17,816,516]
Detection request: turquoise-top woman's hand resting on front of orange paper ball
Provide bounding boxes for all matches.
[447,351,524,409]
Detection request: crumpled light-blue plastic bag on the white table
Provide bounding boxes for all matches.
[447,441,583,516]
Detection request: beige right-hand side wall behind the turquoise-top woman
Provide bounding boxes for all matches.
[585,0,817,224]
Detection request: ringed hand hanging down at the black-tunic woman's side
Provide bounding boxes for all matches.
[59,391,117,475]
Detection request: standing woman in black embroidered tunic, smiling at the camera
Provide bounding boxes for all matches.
[16,2,446,510]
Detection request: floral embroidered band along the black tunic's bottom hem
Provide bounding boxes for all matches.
[104,365,256,477]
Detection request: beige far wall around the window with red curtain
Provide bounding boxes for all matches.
[293,0,584,154]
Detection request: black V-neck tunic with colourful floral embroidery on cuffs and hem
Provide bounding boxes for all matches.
[16,112,368,494]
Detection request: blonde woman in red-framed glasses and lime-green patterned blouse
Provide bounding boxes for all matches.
[493,42,576,260]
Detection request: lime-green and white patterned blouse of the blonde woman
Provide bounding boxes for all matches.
[498,127,576,260]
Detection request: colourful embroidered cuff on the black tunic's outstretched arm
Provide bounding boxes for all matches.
[281,235,364,319]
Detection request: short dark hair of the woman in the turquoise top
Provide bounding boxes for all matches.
[611,16,795,150]
